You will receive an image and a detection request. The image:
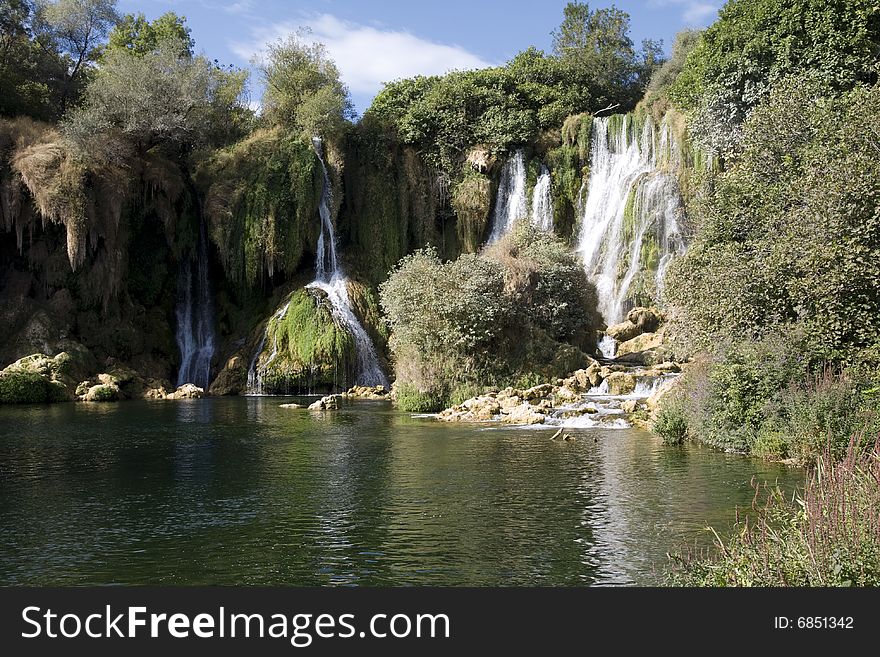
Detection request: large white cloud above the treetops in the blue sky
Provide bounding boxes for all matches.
[230,14,492,95]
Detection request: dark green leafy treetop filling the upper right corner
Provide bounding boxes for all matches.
[669,0,880,152]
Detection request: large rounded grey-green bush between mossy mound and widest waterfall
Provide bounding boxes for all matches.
[379,224,598,410]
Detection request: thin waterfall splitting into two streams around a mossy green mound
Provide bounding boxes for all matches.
[247,137,389,395]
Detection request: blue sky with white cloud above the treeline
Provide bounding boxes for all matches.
[119,0,722,113]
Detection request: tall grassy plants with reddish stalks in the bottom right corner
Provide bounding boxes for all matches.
[668,441,880,587]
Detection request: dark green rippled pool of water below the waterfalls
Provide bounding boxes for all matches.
[0,398,802,586]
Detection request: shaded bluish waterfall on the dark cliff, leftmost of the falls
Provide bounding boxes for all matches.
[177,223,215,390]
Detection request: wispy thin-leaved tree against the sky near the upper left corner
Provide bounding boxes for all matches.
[34,0,119,114]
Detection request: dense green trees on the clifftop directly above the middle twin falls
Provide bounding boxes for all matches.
[367,3,658,174]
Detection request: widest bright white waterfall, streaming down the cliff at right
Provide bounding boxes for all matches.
[578,114,685,324]
